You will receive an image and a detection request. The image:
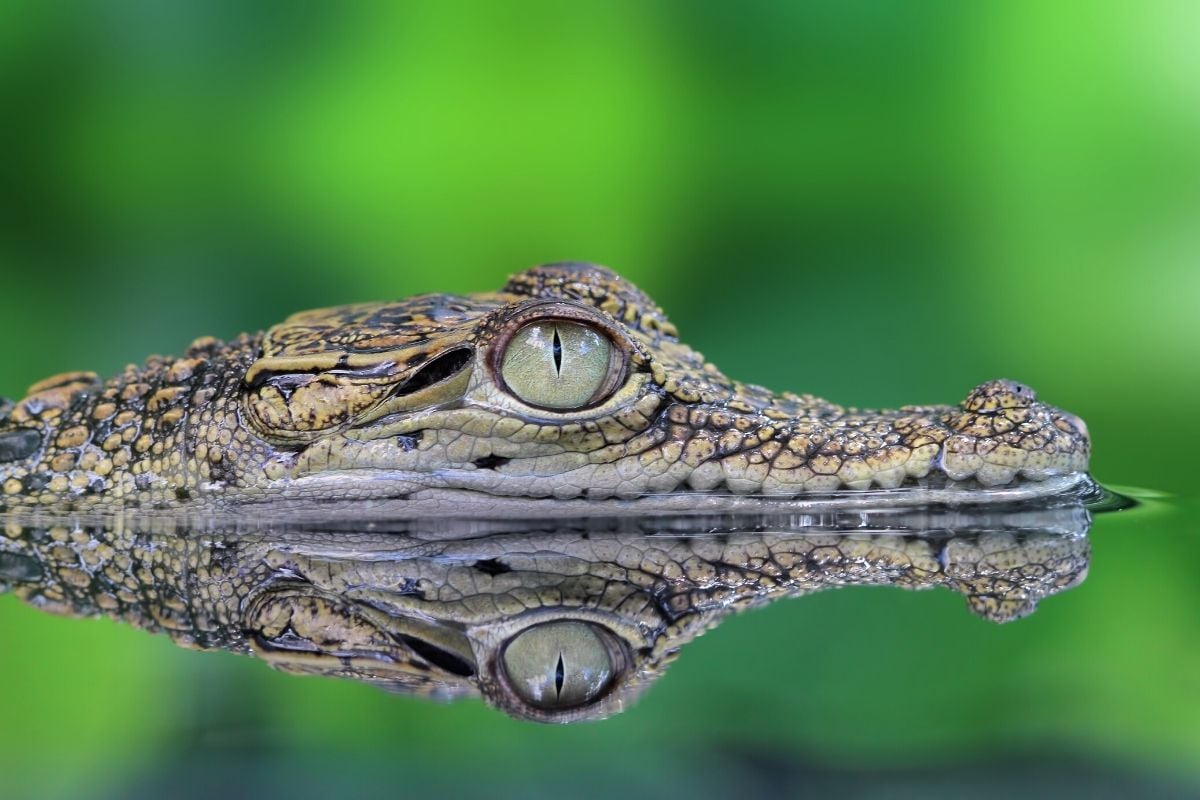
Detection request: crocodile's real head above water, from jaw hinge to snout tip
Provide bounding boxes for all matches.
[229,264,1090,513]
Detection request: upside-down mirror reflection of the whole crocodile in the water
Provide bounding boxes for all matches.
[0,503,1091,722]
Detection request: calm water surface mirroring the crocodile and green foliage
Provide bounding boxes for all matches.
[0,484,1200,798]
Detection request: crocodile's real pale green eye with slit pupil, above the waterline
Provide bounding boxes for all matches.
[500,319,619,409]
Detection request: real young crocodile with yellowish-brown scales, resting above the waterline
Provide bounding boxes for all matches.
[0,263,1091,516]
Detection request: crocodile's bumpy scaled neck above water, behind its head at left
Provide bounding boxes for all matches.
[0,336,260,513]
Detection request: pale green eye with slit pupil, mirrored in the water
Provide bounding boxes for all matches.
[504,621,617,710]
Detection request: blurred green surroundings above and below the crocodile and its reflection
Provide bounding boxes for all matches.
[0,0,1200,796]
